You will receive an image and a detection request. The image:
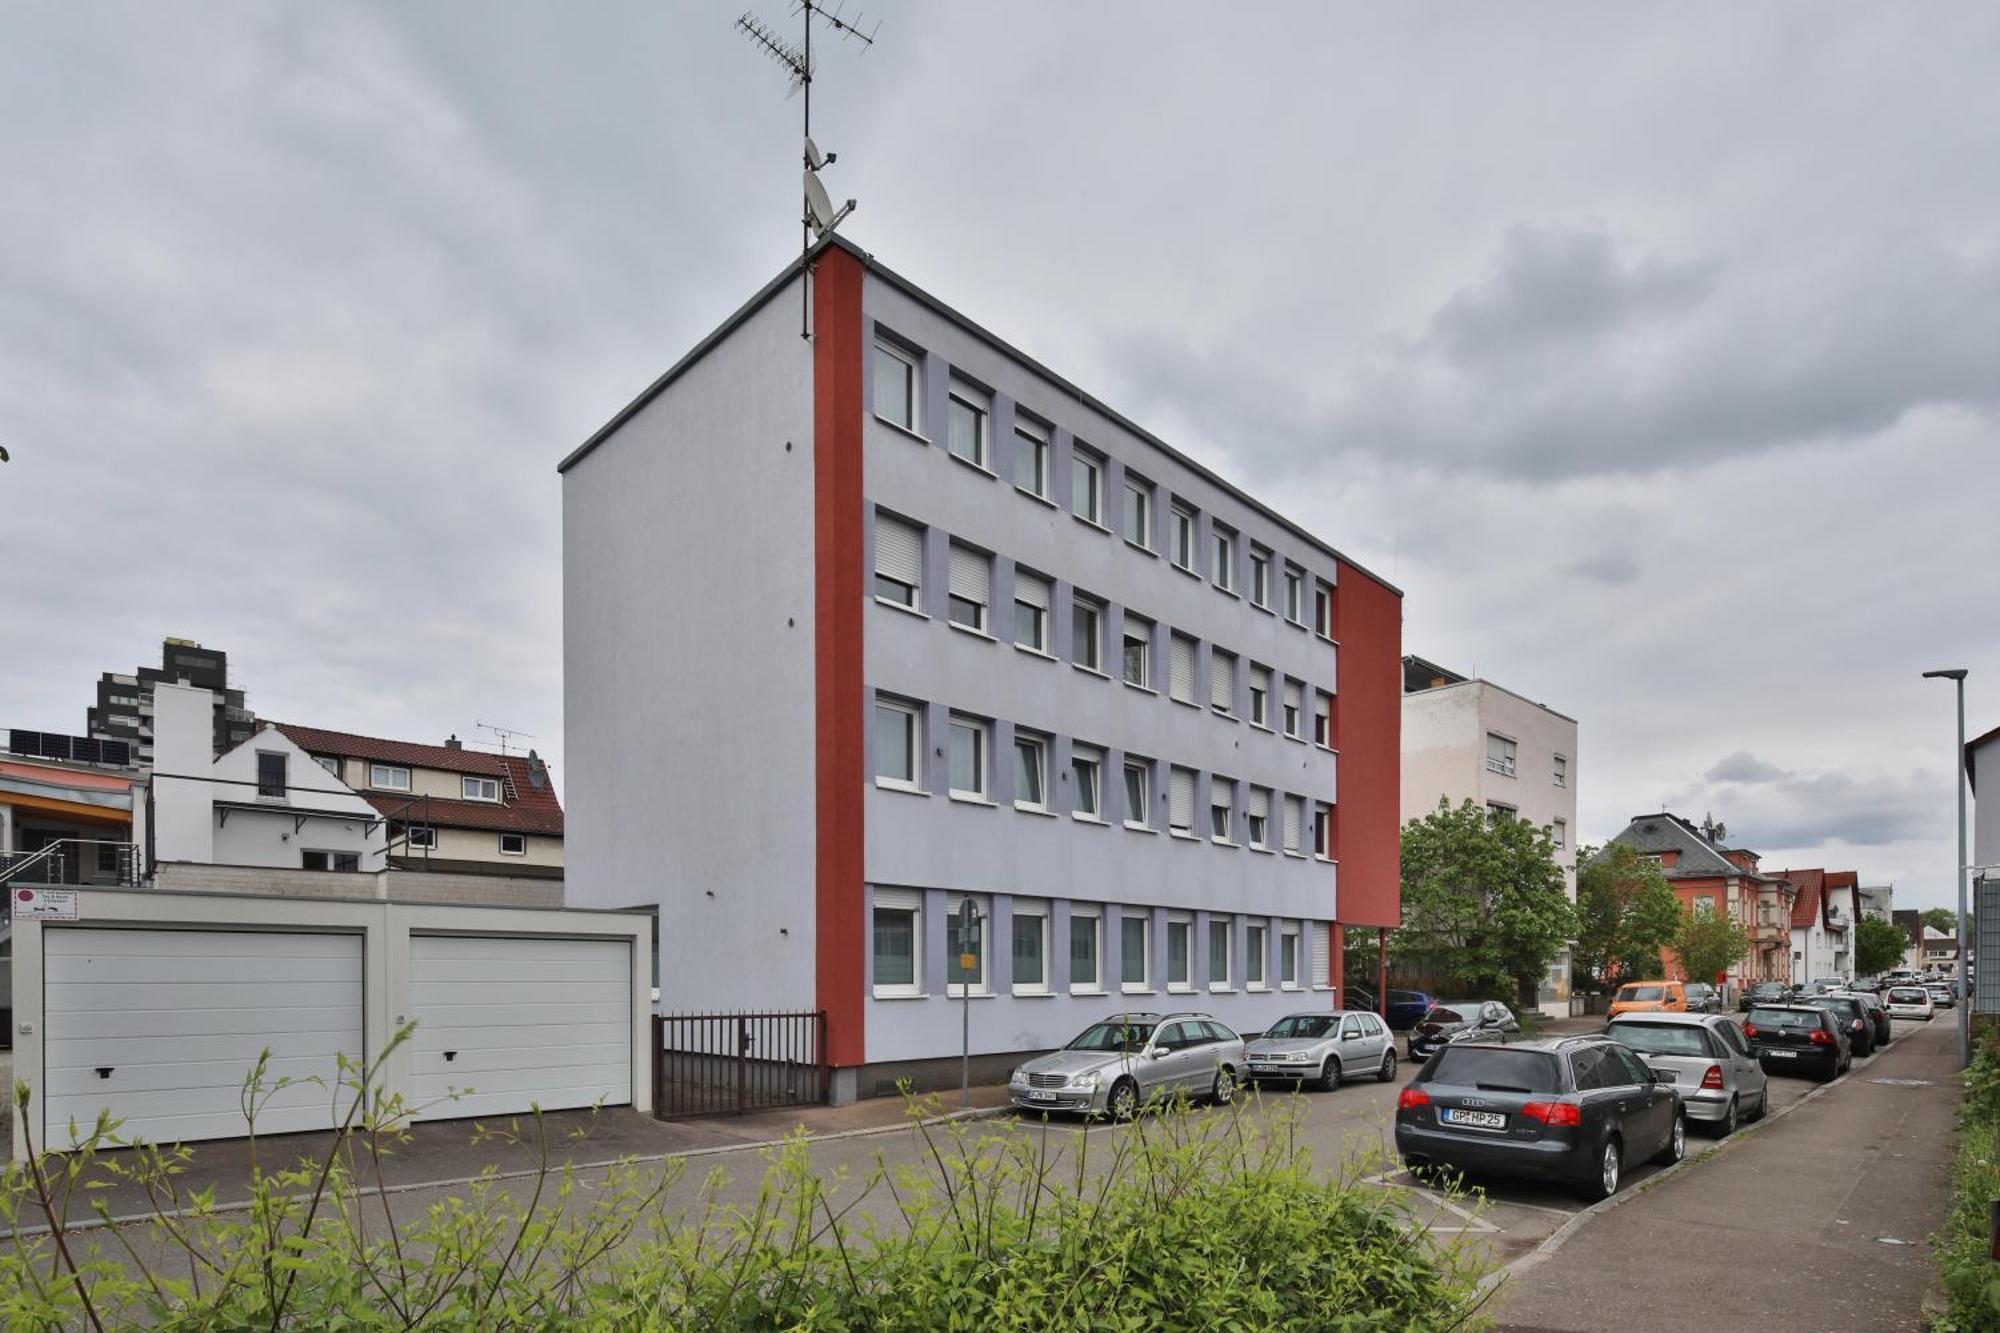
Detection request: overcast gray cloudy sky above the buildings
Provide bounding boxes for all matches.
[0,0,2000,905]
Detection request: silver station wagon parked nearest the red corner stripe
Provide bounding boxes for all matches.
[1008,1013,1244,1121]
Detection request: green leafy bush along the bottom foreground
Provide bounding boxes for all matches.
[0,1039,1480,1333]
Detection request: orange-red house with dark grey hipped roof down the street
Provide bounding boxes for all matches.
[1612,811,1800,987]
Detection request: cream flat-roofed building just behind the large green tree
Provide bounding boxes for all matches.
[1402,656,1576,1015]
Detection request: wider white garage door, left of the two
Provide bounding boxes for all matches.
[42,927,364,1147]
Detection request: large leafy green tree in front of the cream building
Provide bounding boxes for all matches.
[1390,801,1576,1007]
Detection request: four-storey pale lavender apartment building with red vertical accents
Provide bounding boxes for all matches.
[562,238,1402,1101]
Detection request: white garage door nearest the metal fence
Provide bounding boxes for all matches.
[410,935,632,1121]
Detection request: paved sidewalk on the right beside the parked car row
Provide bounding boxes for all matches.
[1494,1017,1958,1333]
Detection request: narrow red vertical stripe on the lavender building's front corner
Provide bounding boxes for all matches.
[812,248,868,1067]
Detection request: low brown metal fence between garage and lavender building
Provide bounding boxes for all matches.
[652,1011,828,1121]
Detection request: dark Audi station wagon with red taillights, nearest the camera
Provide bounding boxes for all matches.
[1396,1037,1688,1199]
